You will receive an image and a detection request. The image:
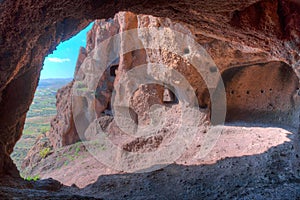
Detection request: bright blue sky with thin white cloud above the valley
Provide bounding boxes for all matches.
[40,23,93,79]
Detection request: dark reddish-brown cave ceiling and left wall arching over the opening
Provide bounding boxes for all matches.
[0,0,300,177]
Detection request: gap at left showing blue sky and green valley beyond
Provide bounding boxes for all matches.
[11,22,92,179]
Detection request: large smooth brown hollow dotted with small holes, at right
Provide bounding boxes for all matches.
[222,62,299,126]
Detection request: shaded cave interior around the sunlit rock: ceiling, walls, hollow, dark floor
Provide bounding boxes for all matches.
[0,0,300,199]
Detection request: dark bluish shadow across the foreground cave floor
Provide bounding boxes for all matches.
[0,124,300,199]
